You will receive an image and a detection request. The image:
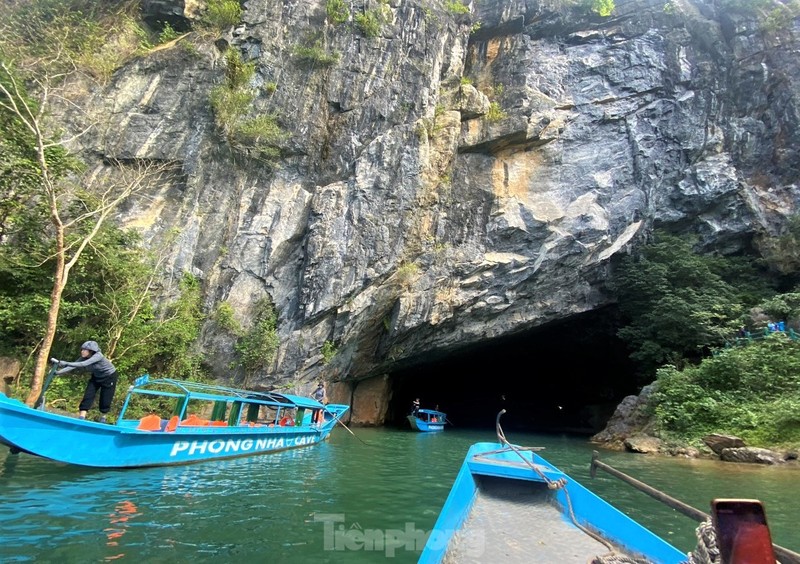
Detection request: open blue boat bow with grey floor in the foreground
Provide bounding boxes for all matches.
[419,442,687,564]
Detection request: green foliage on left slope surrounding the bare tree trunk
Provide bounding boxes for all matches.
[0,7,209,406]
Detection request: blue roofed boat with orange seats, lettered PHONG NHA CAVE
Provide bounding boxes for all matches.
[0,376,348,468]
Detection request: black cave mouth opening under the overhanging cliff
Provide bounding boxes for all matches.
[386,306,643,435]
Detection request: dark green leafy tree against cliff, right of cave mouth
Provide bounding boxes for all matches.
[613,233,764,374]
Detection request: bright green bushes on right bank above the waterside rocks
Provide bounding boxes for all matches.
[650,333,800,446]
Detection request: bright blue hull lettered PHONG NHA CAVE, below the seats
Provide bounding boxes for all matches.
[0,394,347,468]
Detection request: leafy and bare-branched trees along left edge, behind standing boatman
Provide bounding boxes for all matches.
[0,0,209,408]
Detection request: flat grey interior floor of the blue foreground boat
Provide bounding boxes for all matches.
[443,476,636,564]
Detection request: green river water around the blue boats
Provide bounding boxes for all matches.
[0,427,800,563]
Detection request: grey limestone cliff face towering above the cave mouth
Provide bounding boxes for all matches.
[57,0,800,422]
